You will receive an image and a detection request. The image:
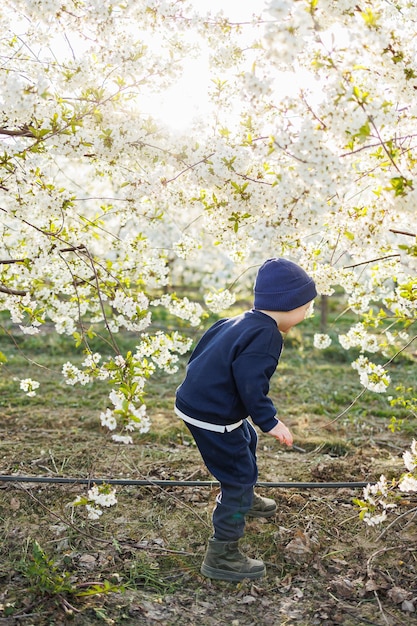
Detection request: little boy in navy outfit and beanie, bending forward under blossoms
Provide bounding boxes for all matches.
[175,258,317,581]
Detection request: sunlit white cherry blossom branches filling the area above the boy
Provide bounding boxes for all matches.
[0,0,417,516]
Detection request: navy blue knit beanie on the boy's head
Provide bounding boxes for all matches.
[254,258,317,311]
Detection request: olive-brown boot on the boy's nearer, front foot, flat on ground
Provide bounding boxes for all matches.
[200,539,266,581]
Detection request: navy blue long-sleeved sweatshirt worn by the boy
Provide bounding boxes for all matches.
[176,309,283,432]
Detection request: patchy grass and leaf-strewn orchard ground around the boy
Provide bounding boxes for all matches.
[0,305,417,626]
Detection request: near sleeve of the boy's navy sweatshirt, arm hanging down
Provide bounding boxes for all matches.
[233,352,278,432]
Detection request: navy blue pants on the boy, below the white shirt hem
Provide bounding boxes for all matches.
[185,420,258,541]
